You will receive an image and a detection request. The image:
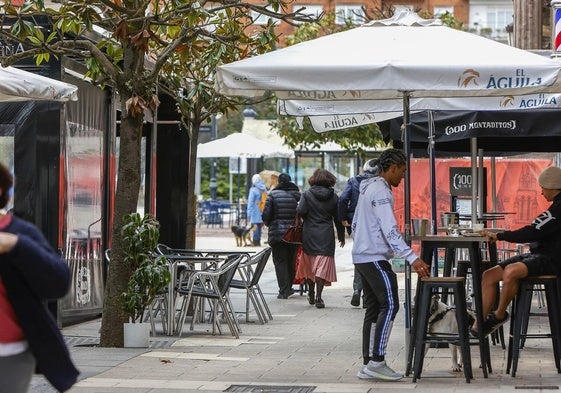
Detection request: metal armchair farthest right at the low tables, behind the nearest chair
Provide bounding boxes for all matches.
[230,247,273,324]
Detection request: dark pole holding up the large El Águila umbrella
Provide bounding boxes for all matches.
[403,91,411,368]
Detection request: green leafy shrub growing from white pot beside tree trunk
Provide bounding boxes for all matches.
[120,213,171,322]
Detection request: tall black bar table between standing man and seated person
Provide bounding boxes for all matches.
[412,234,497,378]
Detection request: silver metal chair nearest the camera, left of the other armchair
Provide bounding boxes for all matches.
[176,254,243,338]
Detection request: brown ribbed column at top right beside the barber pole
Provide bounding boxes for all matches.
[514,0,542,49]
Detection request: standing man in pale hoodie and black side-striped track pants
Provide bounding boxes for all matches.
[352,149,429,381]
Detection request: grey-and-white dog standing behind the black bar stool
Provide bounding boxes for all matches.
[426,295,475,371]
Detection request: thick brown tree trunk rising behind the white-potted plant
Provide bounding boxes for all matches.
[100,112,143,347]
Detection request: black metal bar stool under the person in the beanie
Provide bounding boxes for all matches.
[506,275,561,377]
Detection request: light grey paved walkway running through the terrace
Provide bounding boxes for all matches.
[31,229,561,393]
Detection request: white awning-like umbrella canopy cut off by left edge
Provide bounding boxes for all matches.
[0,67,78,102]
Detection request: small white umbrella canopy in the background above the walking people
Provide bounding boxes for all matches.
[197,133,294,158]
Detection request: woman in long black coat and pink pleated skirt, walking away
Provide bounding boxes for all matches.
[296,169,345,308]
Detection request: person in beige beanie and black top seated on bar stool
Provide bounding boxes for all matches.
[471,166,561,335]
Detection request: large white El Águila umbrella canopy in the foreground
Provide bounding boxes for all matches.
[215,12,560,101]
